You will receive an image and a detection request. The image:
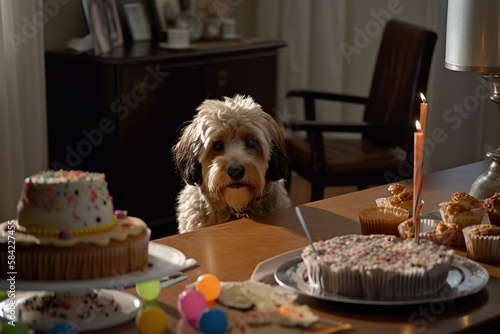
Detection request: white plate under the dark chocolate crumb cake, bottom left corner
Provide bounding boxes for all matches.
[0,290,141,331]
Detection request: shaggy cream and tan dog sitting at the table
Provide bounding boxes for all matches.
[172,95,290,233]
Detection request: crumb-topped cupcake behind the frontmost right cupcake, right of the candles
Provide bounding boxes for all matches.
[439,192,485,246]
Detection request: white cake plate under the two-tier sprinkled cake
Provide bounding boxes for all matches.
[0,242,186,291]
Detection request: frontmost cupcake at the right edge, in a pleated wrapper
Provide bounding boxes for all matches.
[462,224,500,262]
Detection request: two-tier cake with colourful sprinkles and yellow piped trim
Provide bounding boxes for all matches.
[0,170,150,280]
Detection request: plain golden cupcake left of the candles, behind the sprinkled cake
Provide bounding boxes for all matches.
[359,207,409,236]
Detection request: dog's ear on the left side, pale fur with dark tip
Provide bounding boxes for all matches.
[172,123,203,186]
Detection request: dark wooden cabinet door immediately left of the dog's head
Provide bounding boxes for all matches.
[116,64,202,231]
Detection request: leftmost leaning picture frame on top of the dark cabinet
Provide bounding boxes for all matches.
[82,0,111,55]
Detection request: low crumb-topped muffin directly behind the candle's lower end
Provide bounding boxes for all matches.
[398,218,458,246]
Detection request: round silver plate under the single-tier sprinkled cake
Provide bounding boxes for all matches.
[275,256,489,305]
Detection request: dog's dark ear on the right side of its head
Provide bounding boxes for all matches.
[266,115,290,181]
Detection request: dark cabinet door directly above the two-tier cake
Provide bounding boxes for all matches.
[45,58,120,197]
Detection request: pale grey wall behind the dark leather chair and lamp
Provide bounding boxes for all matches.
[308,0,500,172]
